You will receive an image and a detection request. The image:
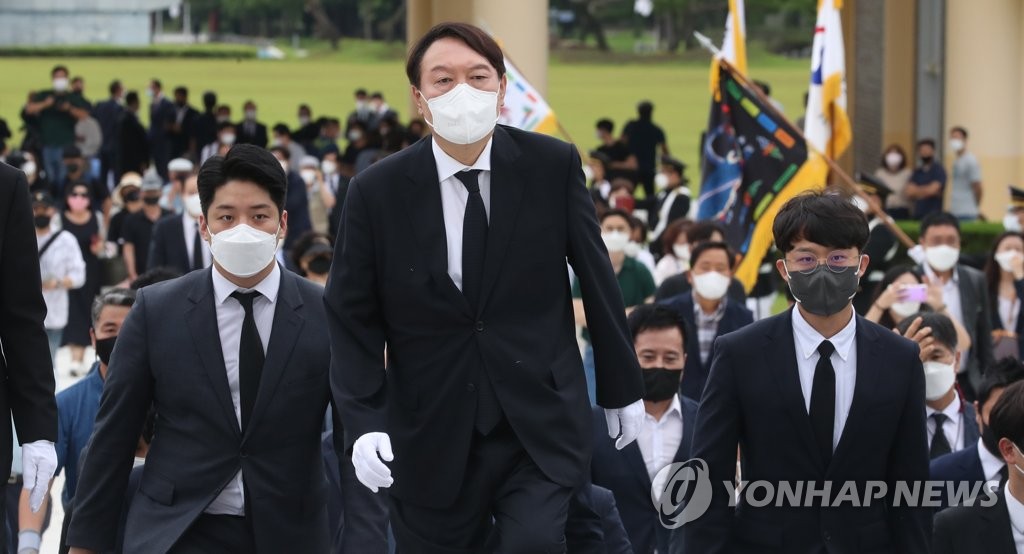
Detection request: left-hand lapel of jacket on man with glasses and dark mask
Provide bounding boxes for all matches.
[762,307,825,472]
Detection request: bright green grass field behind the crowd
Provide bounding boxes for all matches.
[0,41,809,190]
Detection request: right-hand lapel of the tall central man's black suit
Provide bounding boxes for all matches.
[477,127,525,310]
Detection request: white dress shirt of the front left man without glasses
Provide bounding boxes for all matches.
[205,264,281,515]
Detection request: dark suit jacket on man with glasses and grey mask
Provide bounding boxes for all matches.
[682,310,931,554]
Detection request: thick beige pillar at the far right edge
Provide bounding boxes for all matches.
[937,0,1024,221]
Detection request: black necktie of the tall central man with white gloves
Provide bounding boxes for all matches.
[455,169,502,435]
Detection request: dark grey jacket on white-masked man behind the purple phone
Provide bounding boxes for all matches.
[920,263,995,400]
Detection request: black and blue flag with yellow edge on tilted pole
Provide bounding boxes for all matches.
[698,66,824,291]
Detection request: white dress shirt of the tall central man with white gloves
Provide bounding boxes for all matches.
[430,138,494,291]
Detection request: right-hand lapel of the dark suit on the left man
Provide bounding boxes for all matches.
[243,267,305,439]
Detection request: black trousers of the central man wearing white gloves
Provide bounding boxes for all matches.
[390,421,573,554]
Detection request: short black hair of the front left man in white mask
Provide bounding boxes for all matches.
[198,144,288,215]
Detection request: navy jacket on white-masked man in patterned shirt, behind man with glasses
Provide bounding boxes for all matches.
[662,291,754,401]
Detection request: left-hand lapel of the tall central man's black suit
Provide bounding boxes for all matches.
[402,138,473,314]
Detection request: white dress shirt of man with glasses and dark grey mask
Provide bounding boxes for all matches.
[793,307,857,452]
